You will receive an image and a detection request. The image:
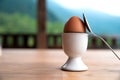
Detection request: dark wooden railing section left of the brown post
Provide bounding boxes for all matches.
[0,34,37,48]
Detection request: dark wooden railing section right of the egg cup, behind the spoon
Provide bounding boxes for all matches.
[88,36,119,49]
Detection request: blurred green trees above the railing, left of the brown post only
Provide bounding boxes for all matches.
[0,13,36,34]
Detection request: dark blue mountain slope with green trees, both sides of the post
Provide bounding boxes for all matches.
[0,0,64,34]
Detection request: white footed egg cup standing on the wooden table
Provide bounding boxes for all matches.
[61,33,88,71]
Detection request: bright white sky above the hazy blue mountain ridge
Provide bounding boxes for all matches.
[53,0,120,16]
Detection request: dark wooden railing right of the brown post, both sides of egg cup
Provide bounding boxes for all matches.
[47,34,120,49]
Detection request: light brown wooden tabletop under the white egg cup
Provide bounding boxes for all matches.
[0,49,120,80]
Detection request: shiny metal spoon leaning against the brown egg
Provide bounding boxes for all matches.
[83,13,120,60]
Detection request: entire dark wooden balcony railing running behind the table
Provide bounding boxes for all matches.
[0,34,120,49]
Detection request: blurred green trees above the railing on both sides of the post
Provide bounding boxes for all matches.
[0,12,64,34]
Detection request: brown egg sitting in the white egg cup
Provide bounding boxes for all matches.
[64,16,86,33]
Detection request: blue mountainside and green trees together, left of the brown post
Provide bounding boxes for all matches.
[0,0,37,34]
